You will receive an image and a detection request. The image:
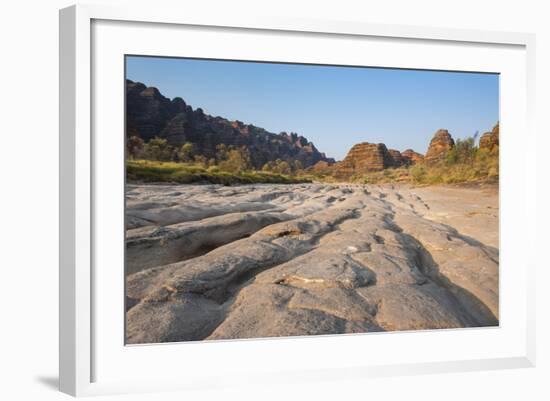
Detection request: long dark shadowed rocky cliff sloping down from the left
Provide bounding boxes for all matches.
[126,80,334,168]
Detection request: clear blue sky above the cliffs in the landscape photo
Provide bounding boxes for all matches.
[126,56,499,160]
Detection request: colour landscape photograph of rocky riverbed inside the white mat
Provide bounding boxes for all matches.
[124,55,500,345]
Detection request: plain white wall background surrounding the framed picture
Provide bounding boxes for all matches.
[0,0,550,401]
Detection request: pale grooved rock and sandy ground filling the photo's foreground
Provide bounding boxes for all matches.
[126,184,499,343]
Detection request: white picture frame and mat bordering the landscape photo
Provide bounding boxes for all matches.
[59,5,537,396]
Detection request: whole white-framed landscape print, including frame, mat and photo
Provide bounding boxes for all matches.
[60,6,537,395]
